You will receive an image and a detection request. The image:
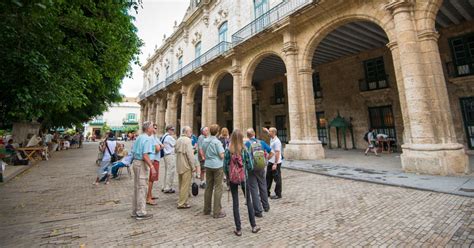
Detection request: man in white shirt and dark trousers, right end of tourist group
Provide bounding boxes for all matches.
[263,127,282,200]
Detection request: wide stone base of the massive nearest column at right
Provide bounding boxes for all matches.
[401,144,469,176]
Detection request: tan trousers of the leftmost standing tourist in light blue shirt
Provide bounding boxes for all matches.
[132,160,150,216]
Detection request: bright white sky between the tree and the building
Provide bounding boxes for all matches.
[120,0,189,97]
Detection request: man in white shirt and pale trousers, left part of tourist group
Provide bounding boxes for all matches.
[160,125,176,194]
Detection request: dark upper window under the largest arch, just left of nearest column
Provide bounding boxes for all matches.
[359,57,388,91]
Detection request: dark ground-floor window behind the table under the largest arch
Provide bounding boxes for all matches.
[369,106,397,139]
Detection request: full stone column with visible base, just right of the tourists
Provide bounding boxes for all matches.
[283,31,325,160]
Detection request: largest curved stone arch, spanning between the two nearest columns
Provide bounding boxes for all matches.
[300,12,396,68]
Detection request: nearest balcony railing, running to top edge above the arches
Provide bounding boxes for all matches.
[232,0,313,46]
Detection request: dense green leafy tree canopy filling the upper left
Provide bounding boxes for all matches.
[0,0,142,127]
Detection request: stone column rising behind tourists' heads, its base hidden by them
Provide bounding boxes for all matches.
[229,62,244,132]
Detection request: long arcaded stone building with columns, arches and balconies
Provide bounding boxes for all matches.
[139,0,474,175]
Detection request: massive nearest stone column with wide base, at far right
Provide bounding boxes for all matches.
[385,0,469,175]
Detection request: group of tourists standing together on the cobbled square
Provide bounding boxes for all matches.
[124,122,283,236]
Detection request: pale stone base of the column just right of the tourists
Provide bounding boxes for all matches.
[283,141,325,160]
